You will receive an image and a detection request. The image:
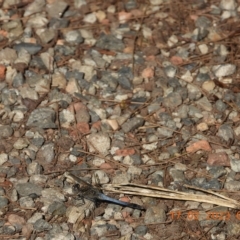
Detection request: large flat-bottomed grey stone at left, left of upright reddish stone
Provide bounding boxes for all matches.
[27,108,57,128]
